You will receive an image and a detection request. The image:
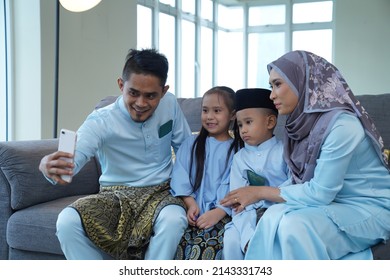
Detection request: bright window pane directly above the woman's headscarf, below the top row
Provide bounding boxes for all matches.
[293,29,332,62]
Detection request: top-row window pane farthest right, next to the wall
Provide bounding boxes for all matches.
[293,1,333,23]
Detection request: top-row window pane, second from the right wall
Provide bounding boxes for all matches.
[249,5,286,26]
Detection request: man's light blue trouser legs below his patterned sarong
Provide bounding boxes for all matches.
[57,205,188,260]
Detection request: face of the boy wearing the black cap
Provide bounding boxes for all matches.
[236,108,276,146]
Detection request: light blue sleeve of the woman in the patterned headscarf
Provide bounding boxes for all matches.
[281,114,365,205]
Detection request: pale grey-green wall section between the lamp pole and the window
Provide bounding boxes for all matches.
[58,0,137,136]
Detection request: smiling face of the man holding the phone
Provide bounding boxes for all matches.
[118,73,169,122]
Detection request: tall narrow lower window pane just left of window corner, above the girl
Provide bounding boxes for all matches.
[199,27,213,96]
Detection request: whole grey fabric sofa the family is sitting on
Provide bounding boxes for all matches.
[0,94,390,260]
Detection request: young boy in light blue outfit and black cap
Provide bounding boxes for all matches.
[221,88,288,260]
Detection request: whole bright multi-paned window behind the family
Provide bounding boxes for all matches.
[130,0,333,97]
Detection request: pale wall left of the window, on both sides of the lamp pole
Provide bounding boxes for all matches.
[10,0,137,140]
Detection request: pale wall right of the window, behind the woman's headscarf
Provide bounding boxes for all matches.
[334,0,390,95]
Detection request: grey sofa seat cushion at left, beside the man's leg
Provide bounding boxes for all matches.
[7,195,84,255]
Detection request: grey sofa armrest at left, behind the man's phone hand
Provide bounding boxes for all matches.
[0,139,99,210]
